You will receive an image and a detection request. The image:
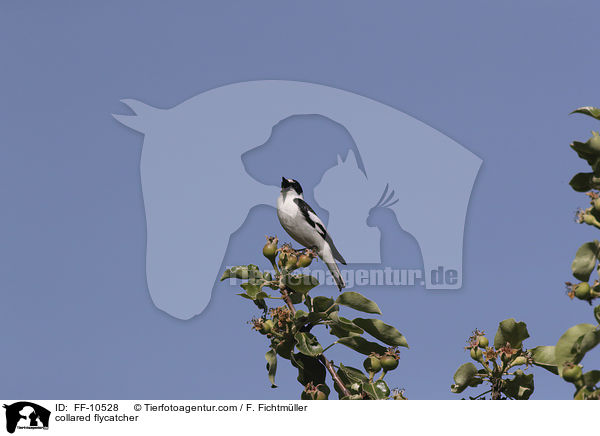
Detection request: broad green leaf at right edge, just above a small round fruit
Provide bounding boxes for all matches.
[554,324,600,375]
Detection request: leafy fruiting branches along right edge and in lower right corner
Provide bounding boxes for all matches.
[451,106,600,400]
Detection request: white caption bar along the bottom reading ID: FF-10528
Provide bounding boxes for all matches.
[0,400,597,436]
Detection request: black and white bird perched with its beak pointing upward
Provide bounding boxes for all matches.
[277,177,346,291]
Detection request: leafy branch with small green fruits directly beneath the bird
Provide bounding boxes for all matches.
[221,237,408,400]
